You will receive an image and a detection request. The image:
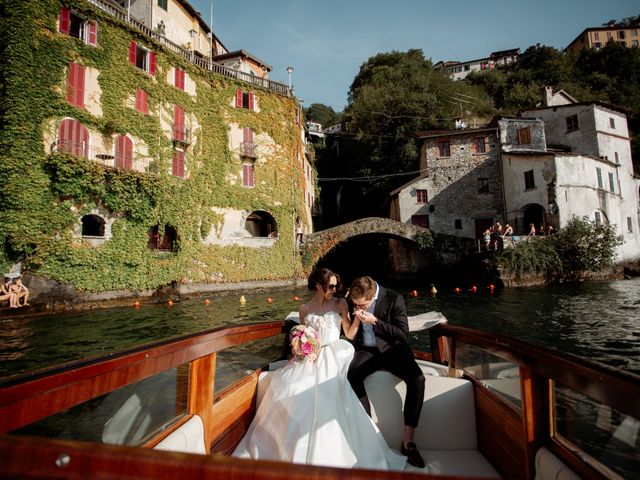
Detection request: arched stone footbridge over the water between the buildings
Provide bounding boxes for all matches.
[301,217,432,275]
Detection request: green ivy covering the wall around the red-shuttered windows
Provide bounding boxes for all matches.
[0,0,305,291]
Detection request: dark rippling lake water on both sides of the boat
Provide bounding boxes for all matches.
[0,278,640,377]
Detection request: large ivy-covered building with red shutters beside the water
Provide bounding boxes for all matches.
[0,0,315,291]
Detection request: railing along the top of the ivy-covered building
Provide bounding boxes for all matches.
[88,0,293,97]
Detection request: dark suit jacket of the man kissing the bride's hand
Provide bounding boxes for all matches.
[350,284,409,352]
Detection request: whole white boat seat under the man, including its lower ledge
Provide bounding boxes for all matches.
[365,368,500,478]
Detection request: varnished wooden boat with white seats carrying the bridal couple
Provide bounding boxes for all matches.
[0,312,640,480]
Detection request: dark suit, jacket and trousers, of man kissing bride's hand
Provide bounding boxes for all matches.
[348,284,425,427]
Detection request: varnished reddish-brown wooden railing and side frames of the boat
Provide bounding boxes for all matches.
[0,321,640,479]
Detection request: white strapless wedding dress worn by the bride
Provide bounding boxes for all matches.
[233,312,407,470]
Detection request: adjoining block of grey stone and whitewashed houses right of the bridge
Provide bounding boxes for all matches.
[390,87,640,262]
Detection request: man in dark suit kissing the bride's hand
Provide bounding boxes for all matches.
[348,276,425,468]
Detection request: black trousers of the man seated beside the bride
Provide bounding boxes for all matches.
[347,345,425,427]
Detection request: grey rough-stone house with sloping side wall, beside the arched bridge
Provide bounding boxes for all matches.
[390,125,504,238]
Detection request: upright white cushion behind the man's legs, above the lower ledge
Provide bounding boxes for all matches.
[365,371,478,450]
